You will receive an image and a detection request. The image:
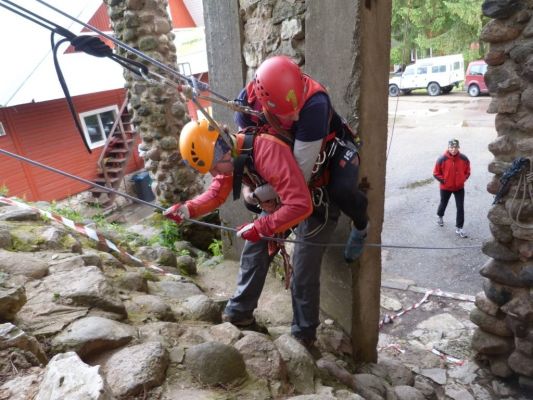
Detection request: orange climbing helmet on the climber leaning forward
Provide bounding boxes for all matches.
[179,119,219,174]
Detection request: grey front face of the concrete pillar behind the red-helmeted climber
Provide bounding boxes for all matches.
[304,0,360,340]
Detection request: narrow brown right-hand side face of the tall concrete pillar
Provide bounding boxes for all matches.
[352,0,392,362]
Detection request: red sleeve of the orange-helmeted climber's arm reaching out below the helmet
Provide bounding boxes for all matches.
[185,175,233,218]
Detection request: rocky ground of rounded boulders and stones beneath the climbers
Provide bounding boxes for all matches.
[0,198,532,400]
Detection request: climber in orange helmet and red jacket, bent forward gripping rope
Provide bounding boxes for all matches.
[164,120,313,327]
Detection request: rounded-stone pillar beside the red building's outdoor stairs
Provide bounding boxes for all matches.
[105,0,200,204]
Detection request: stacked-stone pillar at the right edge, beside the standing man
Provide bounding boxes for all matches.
[470,0,533,390]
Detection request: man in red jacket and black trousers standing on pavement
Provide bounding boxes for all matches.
[433,139,470,238]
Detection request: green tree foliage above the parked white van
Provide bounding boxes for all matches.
[391,0,487,64]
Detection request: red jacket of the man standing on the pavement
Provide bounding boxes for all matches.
[433,150,470,192]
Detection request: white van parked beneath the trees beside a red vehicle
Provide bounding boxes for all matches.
[389,54,465,97]
